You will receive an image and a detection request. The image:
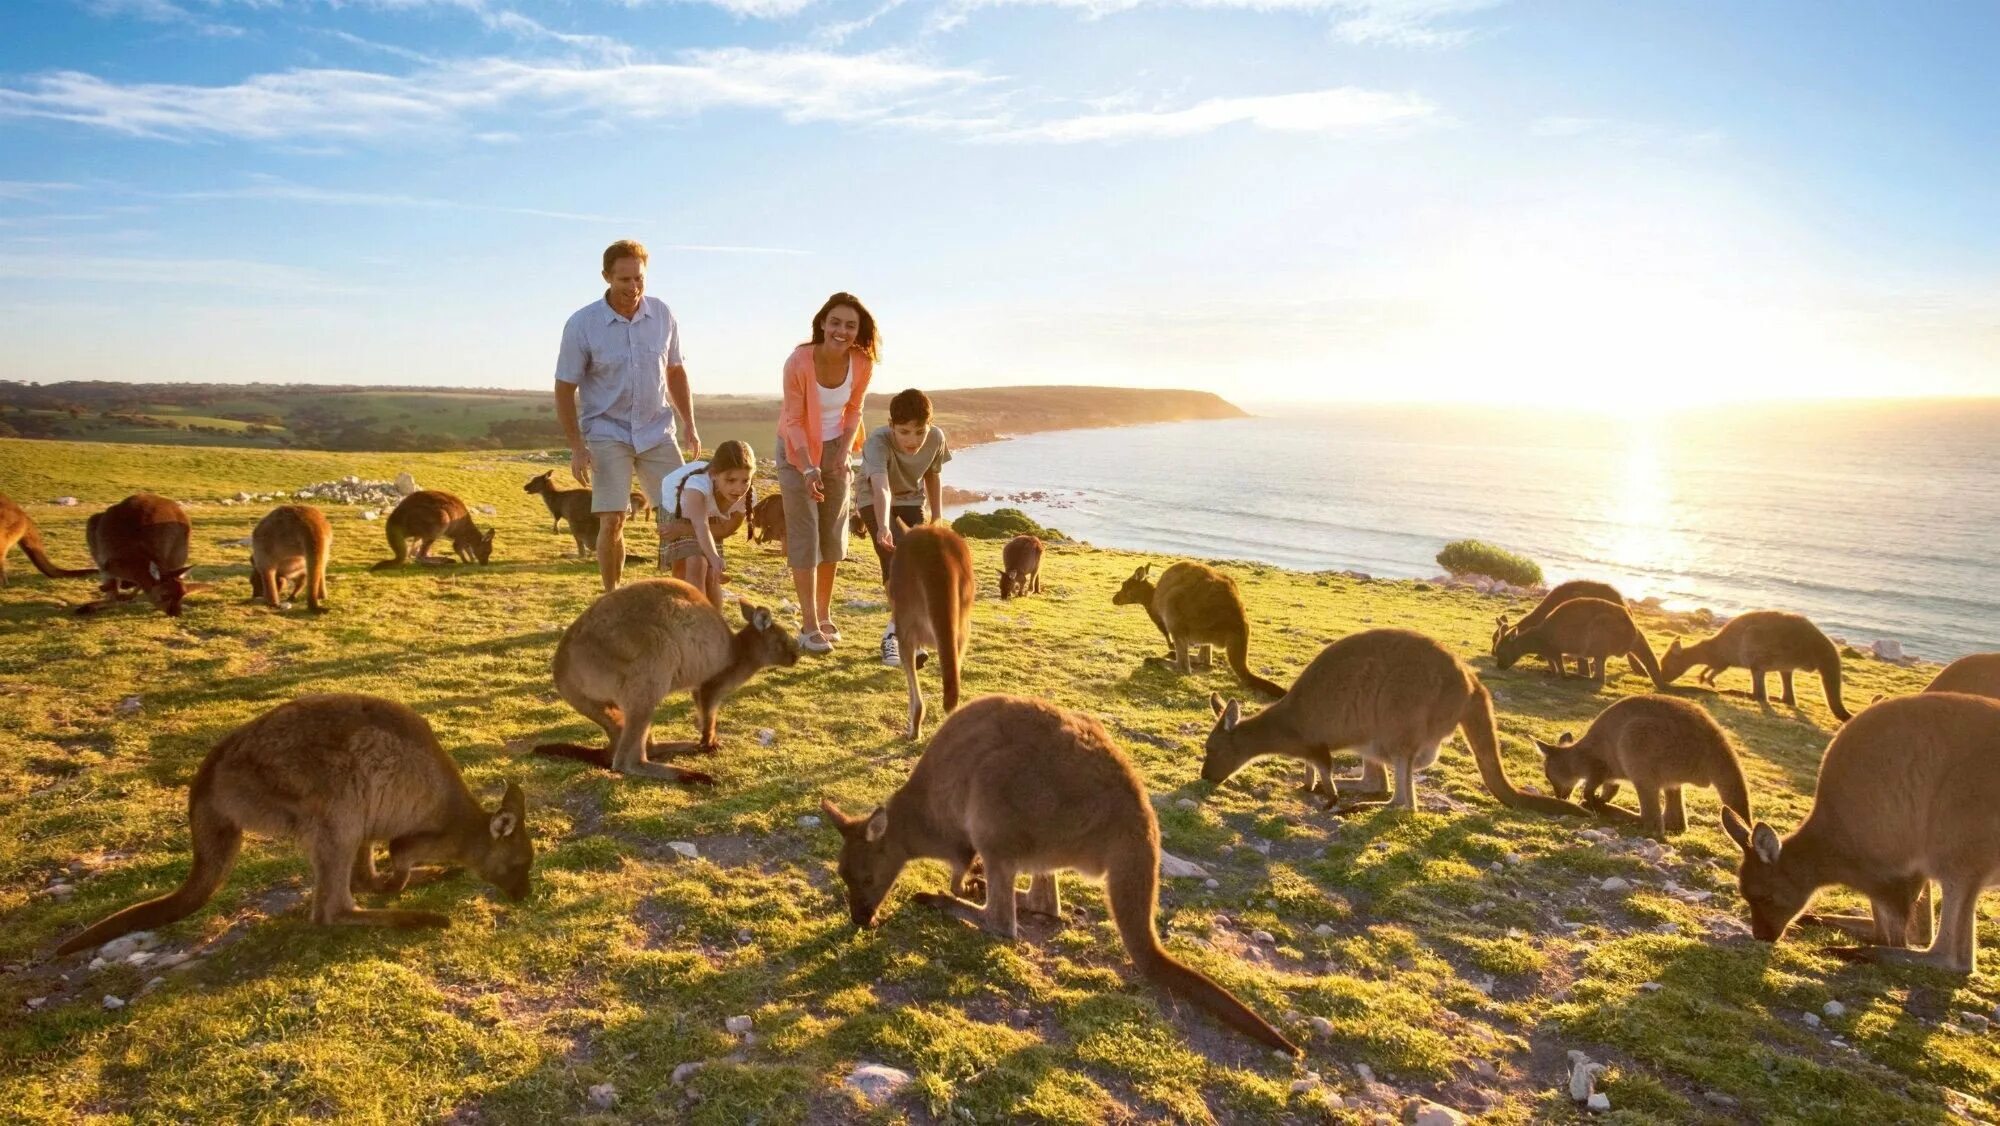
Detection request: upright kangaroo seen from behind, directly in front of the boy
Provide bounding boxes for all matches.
[888,524,976,740]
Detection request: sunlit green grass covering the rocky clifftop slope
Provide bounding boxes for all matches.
[0,442,2000,1124]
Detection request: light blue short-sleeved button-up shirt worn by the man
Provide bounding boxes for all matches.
[556,296,680,452]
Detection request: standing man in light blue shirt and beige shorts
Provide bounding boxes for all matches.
[556,238,702,590]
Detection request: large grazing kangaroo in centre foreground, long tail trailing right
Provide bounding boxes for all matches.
[820,696,1298,1054]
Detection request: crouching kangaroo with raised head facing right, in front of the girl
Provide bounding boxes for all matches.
[534,578,798,784]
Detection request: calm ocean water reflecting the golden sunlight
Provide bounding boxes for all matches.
[944,400,2000,660]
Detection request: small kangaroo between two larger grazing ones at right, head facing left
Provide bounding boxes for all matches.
[1534,696,1750,834]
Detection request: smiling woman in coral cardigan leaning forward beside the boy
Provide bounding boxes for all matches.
[778,294,880,652]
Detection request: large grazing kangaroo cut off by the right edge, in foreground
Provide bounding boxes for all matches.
[1722,692,2000,974]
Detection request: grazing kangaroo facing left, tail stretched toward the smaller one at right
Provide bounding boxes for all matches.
[1202,630,1590,816]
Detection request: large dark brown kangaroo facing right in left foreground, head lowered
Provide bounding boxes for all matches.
[56,696,534,954]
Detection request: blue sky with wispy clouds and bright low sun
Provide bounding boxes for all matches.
[0,0,2000,412]
